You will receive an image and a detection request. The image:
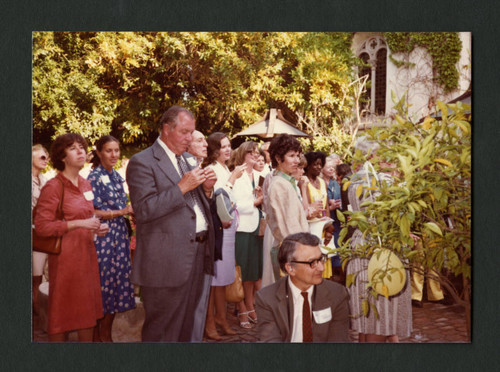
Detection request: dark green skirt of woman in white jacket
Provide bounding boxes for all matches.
[234,229,263,282]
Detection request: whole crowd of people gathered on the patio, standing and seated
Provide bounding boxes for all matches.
[32,106,428,342]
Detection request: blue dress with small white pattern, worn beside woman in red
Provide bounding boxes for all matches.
[88,165,135,314]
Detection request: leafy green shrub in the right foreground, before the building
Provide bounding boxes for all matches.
[341,93,471,338]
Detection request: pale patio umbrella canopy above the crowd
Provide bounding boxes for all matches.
[236,109,310,138]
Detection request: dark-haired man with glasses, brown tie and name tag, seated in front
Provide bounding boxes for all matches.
[256,233,350,342]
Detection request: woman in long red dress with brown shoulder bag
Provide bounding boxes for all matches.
[35,133,109,342]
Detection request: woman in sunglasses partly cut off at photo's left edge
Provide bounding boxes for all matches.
[31,144,49,314]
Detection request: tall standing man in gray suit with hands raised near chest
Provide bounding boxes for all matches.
[127,106,216,342]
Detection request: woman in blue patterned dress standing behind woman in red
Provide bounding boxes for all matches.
[87,136,135,342]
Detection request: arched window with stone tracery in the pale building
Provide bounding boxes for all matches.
[357,36,387,115]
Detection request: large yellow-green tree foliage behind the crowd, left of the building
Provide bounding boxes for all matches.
[33,32,358,153]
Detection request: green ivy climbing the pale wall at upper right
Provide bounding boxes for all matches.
[384,32,462,92]
